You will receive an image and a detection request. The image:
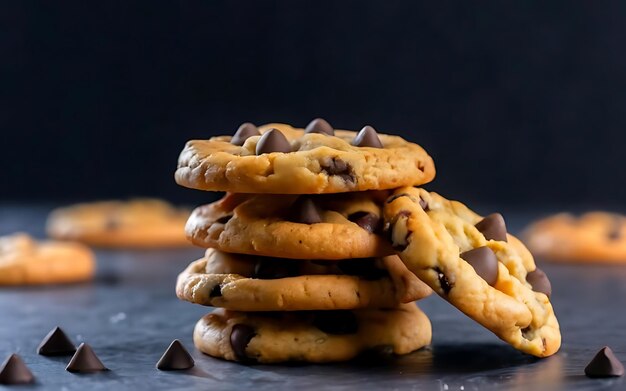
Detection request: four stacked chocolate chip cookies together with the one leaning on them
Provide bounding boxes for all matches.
[176,119,561,363]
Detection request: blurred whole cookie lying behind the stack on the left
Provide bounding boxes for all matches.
[47,199,189,248]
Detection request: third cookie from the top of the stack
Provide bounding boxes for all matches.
[176,249,431,311]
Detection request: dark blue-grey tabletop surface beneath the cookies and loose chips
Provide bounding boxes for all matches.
[0,205,626,391]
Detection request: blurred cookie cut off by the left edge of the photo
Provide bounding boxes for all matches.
[0,234,95,285]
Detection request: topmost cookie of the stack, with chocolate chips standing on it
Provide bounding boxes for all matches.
[175,119,435,194]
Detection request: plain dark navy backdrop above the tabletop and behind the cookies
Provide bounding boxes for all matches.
[0,1,626,208]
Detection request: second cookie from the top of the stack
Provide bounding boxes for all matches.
[185,191,393,259]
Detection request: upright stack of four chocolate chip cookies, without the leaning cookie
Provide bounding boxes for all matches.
[176,119,435,363]
